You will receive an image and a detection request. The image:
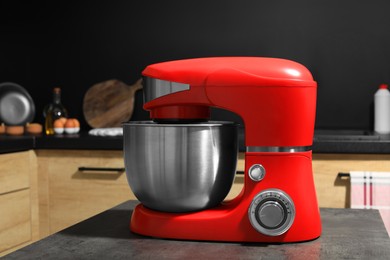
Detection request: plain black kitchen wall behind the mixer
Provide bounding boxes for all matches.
[0,0,390,130]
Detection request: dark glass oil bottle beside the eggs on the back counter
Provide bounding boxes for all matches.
[43,88,68,135]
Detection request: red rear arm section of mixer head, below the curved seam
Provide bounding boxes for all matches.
[205,67,316,147]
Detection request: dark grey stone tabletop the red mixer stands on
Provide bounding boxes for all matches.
[4,201,390,259]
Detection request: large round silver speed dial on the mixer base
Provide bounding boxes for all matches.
[248,189,295,236]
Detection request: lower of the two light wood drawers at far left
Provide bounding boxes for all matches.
[0,189,31,252]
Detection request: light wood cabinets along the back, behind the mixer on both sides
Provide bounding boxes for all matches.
[29,150,390,232]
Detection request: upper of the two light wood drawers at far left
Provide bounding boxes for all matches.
[0,152,30,194]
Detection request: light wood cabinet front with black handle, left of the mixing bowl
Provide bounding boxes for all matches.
[36,150,135,237]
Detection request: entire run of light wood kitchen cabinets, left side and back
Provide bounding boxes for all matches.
[0,139,390,255]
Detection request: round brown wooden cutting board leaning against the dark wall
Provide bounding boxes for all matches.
[83,79,142,128]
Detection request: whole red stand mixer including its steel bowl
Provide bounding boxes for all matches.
[124,57,321,243]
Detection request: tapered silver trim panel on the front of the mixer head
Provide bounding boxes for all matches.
[143,77,190,103]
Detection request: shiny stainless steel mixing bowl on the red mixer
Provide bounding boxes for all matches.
[123,121,238,212]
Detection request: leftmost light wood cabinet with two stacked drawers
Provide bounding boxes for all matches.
[0,150,39,255]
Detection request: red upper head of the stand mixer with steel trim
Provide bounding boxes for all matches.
[142,57,316,147]
